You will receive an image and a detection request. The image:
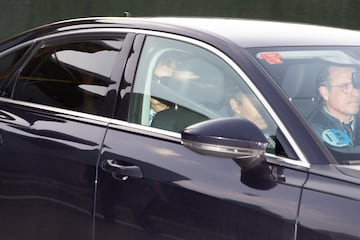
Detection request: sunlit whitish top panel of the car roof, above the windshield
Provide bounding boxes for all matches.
[144,18,360,48]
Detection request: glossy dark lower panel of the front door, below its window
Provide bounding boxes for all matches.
[96,125,307,239]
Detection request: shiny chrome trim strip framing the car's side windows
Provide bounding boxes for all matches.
[1,27,310,168]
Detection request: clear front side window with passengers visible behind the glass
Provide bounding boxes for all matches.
[129,37,284,155]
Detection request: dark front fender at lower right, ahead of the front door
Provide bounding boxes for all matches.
[298,165,360,240]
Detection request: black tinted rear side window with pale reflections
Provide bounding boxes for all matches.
[12,39,122,115]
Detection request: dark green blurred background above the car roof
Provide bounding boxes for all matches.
[0,0,360,40]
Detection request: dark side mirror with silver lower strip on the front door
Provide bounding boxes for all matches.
[181,118,268,169]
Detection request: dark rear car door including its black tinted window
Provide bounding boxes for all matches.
[0,33,129,240]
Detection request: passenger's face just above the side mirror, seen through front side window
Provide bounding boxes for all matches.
[230,94,268,129]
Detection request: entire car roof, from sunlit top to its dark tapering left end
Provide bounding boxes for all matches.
[0,17,360,50]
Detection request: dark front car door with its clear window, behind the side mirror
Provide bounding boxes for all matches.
[95,35,307,239]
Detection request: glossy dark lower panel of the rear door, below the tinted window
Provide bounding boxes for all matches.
[0,104,105,239]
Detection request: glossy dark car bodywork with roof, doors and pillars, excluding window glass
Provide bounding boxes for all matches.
[0,18,360,240]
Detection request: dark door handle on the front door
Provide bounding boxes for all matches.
[103,159,143,180]
